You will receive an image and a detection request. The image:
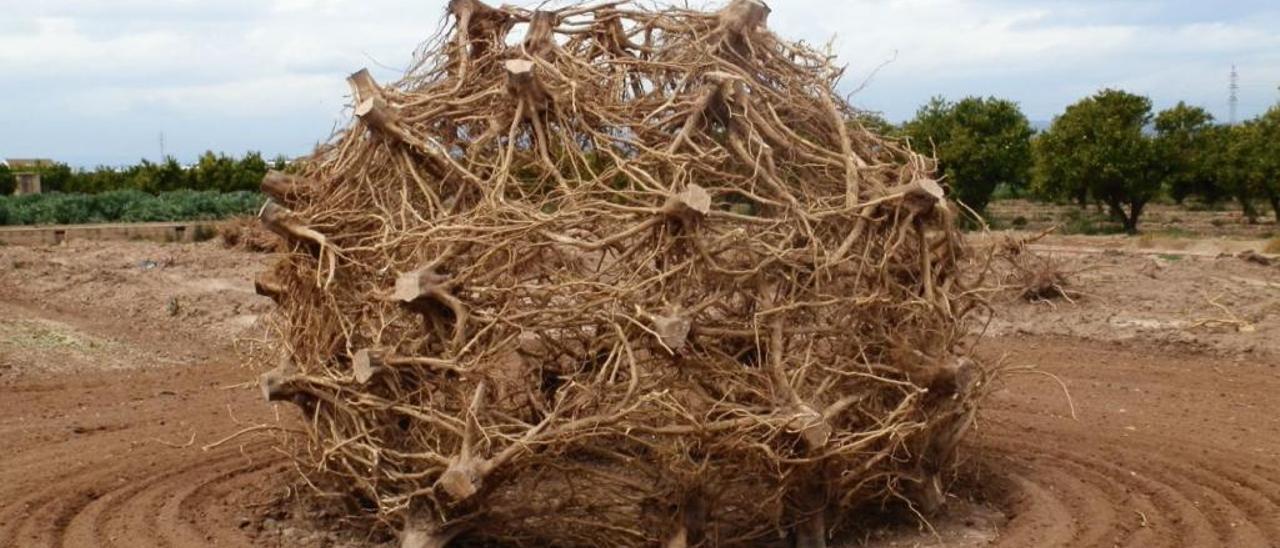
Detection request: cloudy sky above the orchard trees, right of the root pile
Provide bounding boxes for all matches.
[752,0,1280,119]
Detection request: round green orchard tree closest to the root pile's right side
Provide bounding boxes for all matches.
[904,97,1033,211]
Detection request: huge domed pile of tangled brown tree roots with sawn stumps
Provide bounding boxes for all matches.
[249,0,988,547]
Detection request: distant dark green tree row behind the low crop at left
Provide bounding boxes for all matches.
[0,152,288,195]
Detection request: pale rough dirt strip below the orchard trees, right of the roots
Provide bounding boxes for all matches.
[988,231,1280,361]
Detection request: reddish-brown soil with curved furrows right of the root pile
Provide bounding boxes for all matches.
[972,338,1280,547]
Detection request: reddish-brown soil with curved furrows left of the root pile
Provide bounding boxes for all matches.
[0,355,291,547]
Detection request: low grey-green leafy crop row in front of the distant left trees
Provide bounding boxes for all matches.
[0,191,265,225]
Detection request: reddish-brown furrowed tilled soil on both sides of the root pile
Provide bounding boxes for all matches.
[0,322,1280,547]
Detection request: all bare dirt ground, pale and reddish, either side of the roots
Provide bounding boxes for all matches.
[0,238,1280,547]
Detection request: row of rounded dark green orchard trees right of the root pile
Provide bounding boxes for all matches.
[891,90,1280,232]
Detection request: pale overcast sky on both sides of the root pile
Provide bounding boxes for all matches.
[0,0,1280,165]
